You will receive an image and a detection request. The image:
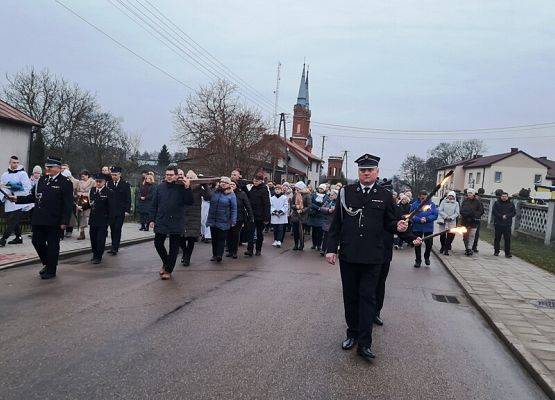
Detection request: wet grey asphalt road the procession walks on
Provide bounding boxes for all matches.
[0,236,546,400]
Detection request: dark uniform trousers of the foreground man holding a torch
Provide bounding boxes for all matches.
[339,259,381,347]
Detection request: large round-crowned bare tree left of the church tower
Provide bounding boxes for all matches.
[173,80,268,174]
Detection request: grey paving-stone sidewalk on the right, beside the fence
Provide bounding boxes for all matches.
[434,237,555,398]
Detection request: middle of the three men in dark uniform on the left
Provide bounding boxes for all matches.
[89,173,116,264]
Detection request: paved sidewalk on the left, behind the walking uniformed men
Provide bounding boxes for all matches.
[0,222,154,269]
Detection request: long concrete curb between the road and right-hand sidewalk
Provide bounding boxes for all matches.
[432,248,555,400]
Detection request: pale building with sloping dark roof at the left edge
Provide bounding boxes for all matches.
[0,100,42,171]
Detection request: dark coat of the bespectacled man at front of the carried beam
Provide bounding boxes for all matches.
[149,182,193,235]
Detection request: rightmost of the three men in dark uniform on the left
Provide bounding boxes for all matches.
[107,167,131,256]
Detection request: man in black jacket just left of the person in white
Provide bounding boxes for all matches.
[245,174,270,257]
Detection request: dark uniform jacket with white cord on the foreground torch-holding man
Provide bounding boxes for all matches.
[328,183,406,264]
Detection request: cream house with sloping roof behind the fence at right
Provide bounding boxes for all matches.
[437,148,555,195]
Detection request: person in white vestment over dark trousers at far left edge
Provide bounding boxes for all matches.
[0,156,33,247]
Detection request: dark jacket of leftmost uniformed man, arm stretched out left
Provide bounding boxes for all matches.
[16,174,73,226]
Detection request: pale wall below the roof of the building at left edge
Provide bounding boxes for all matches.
[0,121,31,170]
